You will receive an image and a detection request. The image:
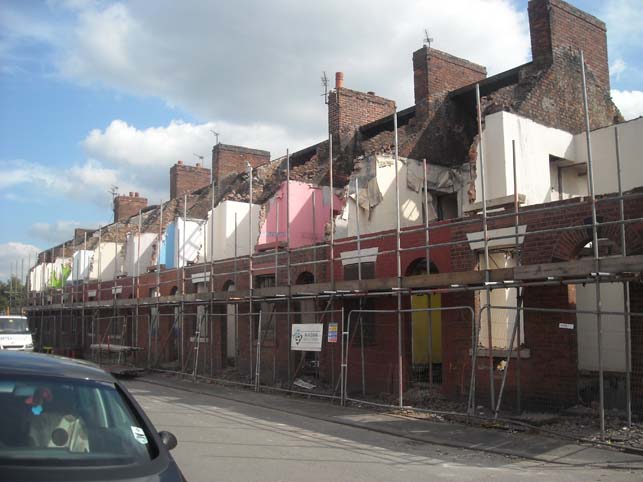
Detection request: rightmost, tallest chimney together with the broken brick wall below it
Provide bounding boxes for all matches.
[483,0,622,134]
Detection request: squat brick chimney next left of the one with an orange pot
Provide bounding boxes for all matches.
[212,143,270,189]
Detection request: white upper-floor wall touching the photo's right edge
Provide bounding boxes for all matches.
[574,118,643,194]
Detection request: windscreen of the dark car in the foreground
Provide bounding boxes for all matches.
[0,374,158,467]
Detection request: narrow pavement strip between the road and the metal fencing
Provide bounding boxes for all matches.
[136,374,643,475]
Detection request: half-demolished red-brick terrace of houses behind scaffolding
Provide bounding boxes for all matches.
[22,0,643,430]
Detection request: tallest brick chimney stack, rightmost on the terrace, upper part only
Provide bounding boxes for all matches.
[528,0,610,91]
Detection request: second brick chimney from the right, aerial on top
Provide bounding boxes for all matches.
[413,45,487,118]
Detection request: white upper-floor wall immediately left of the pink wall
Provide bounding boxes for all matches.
[204,201,261,261]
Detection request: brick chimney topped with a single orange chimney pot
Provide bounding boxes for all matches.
[328,72,395,149]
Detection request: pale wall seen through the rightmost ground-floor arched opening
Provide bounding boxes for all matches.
[576,283,625,372]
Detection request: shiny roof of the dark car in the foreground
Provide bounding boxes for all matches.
[0,350,115,383]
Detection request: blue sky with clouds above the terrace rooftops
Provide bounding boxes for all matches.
[0,0,643,279]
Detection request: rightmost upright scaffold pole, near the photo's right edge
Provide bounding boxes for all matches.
[614,127,632,427]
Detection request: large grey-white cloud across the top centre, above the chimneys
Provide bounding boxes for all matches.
[49,0,529,141]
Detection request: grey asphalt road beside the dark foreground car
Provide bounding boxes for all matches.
[127,380,641,482]
